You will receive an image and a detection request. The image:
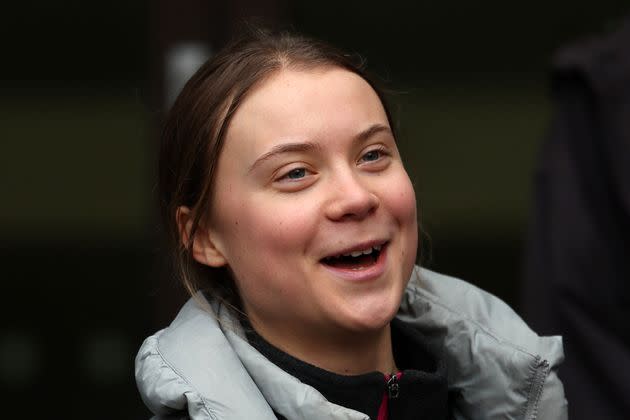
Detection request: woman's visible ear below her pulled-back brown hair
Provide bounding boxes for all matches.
[175,206,227,267]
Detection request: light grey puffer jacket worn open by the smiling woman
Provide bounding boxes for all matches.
[136,267,567,420]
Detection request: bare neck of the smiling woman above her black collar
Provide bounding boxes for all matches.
[250,318,397,375]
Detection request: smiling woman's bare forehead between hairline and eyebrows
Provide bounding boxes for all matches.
[225,67,389,154]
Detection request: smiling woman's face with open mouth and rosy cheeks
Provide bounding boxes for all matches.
[207,67,418,340]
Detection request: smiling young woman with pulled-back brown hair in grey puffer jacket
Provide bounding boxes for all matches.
[136,31,566,420]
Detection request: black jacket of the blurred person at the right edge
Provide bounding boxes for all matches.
[522,16,630,420]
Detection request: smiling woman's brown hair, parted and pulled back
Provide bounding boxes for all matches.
[159,28,394,307]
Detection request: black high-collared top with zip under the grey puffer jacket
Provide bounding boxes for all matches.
[244,319,449,420]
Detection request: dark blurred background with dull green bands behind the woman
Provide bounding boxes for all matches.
[0,0,628,419]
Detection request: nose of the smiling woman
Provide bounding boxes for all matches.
[326,173,380,221]
